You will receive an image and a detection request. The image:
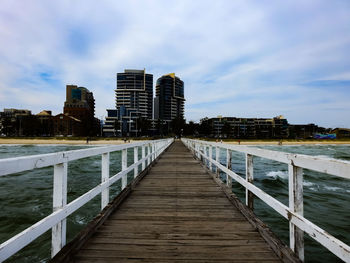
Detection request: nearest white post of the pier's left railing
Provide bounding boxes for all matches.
[51,162,68,257]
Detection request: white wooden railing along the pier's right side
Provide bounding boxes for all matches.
[182,138,350,262]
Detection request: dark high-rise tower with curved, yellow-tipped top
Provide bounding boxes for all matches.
[154,73,185,121]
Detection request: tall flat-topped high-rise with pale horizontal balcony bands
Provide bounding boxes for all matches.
[115,69,153,134]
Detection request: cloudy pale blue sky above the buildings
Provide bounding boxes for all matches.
[0,0,350,128]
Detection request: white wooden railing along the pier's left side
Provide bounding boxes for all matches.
[0,139,173,262]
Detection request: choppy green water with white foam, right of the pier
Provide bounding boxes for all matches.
[214,145,350,262]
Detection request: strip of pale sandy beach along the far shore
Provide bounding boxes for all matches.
[0,138,350,146]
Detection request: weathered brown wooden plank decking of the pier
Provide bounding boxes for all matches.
[67,142,279,263]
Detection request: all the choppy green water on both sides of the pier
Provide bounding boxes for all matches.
[0,145,350,262]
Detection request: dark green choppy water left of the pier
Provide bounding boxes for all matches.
[0,145,136,262]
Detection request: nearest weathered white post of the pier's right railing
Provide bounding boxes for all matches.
[288,164,304,261]
